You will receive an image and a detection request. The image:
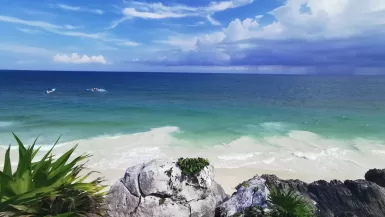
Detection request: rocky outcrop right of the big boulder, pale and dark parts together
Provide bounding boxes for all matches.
[216,173,385,217]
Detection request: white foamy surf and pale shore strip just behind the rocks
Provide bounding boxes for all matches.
[0,126,385,185]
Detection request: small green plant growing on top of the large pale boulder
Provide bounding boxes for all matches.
[177,157,210,176]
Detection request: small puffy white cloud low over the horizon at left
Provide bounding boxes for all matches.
[53,53,107,64]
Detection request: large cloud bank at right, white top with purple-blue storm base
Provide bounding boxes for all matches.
[136,0,385,69]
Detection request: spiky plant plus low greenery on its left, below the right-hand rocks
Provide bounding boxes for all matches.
[228,188,315,217]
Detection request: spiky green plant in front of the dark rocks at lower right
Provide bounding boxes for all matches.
[268,188,314,217]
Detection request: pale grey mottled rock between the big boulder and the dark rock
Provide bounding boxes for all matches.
[216,176,269,217]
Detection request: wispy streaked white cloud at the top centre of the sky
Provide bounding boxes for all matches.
[109,0,254,29]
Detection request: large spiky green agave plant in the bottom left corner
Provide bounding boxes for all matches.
[0,134,106,217]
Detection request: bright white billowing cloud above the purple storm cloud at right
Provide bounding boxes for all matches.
[163,0,385,49]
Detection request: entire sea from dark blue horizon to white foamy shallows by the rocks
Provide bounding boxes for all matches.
[0,71,385,184]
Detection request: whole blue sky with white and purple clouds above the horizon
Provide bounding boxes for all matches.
[0,0,385,74]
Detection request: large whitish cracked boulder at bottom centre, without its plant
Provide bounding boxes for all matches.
[106,159,227,217]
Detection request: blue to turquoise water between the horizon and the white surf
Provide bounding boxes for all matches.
[0,72,385,144]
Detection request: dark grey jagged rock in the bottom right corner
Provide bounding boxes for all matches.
[262,175,385,217]
